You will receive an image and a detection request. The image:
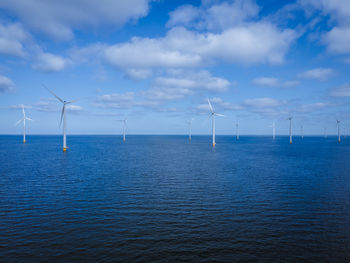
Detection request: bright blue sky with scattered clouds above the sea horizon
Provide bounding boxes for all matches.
[0,0,350,135]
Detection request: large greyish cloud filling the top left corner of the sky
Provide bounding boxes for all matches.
[0,0,153,40]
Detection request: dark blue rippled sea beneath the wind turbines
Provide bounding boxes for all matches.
[0,136,350,262]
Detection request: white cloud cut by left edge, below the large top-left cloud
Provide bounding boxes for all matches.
[0,24,27,57]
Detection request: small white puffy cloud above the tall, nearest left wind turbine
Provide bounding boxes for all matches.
[33,52,66,72]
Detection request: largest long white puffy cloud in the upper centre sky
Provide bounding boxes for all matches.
[105,23,296,69]
